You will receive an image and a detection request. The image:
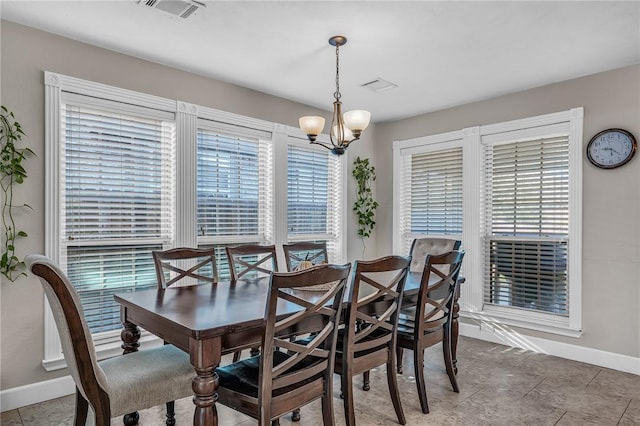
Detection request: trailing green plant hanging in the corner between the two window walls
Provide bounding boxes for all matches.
[351,157,378,255]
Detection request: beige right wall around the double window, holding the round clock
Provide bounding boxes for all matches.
[375,65,640,357]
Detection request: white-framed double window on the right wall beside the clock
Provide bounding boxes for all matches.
[394,108,583,336]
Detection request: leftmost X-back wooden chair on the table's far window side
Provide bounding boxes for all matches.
[151,247,218,289]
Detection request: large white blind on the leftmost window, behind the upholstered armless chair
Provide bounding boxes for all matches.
[60,99,175,333]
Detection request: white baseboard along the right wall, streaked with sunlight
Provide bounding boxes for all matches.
[460,322,640,375]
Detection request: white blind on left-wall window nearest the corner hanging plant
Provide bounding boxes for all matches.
[287,144,343,262]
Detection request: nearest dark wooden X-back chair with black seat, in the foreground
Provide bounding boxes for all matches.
[216,264,351,426]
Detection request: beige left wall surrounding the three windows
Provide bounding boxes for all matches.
[0,21,376,389]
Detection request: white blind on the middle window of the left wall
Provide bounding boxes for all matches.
[197,120,273,279]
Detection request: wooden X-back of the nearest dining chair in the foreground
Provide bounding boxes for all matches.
[260,264,351,413]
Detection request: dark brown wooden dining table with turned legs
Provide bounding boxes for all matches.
[114,272,464,426]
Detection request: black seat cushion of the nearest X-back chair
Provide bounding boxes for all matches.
[216,351,323,398]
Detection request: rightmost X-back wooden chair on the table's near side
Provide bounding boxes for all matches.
[396,250,464,414]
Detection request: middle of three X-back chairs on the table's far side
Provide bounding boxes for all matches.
[226,244,278,281]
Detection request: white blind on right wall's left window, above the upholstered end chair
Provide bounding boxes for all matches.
[400,147,463,253]
